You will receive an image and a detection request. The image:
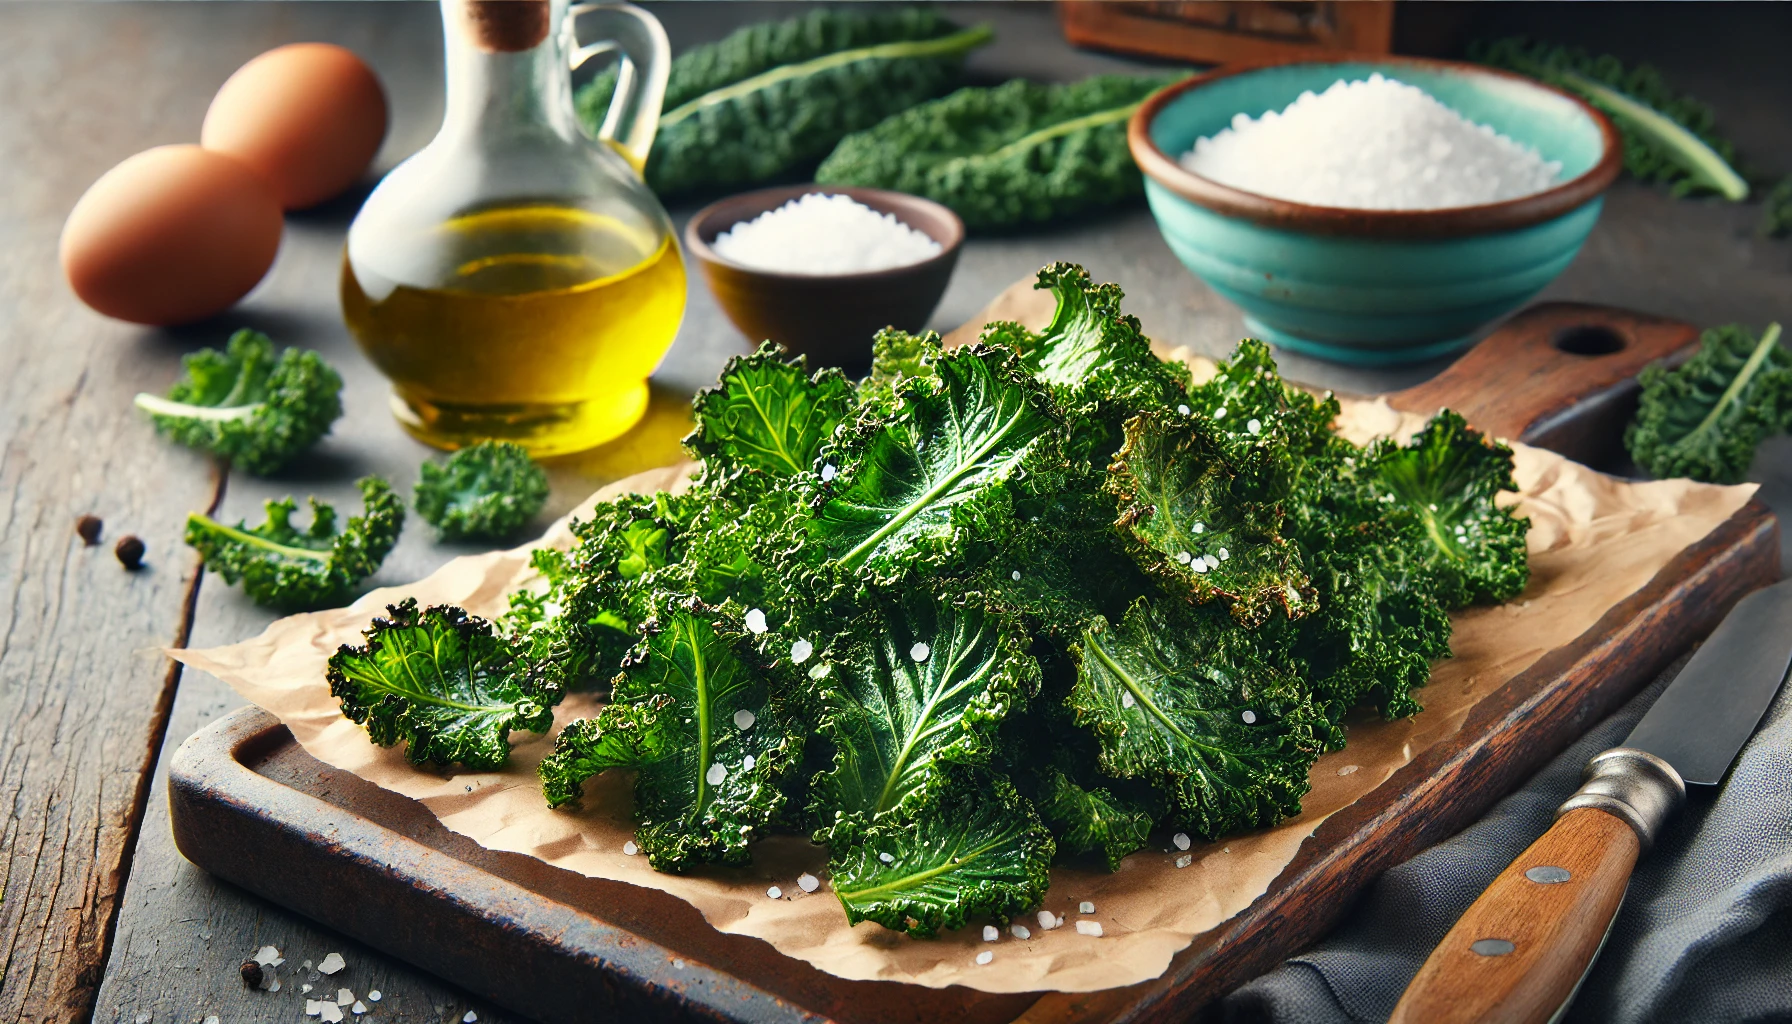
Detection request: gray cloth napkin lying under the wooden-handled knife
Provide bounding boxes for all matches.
[1202,658,1792,1024]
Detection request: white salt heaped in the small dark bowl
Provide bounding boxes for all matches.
[710,192,939,274]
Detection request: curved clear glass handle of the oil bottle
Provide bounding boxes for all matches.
[568,4,672,170]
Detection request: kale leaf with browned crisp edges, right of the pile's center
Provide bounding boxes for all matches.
[1106,414,1315,626]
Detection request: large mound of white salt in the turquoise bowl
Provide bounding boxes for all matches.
[1181,74,1561,210]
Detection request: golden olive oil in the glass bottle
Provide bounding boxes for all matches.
[342,204,685,456]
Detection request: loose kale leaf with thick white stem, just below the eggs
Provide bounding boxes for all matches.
[136,330,342,475]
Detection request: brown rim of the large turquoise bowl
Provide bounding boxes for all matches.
[1125,56,1624,239]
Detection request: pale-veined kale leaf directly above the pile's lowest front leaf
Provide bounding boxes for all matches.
[810,590,1039,829]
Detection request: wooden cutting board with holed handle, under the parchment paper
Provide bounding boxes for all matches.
[168,303,1779,1024]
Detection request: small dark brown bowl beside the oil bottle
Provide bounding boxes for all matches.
[685,185,964,373]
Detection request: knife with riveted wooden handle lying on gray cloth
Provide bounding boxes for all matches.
[1389,579,1792,1024]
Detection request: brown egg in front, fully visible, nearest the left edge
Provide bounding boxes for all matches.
[63,145,283,325]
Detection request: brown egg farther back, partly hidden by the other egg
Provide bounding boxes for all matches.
[199,43,385,210]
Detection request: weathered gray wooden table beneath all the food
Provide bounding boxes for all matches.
[0,2,1792,1024]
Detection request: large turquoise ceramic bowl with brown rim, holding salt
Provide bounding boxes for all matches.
[1127,57,1624,364]
